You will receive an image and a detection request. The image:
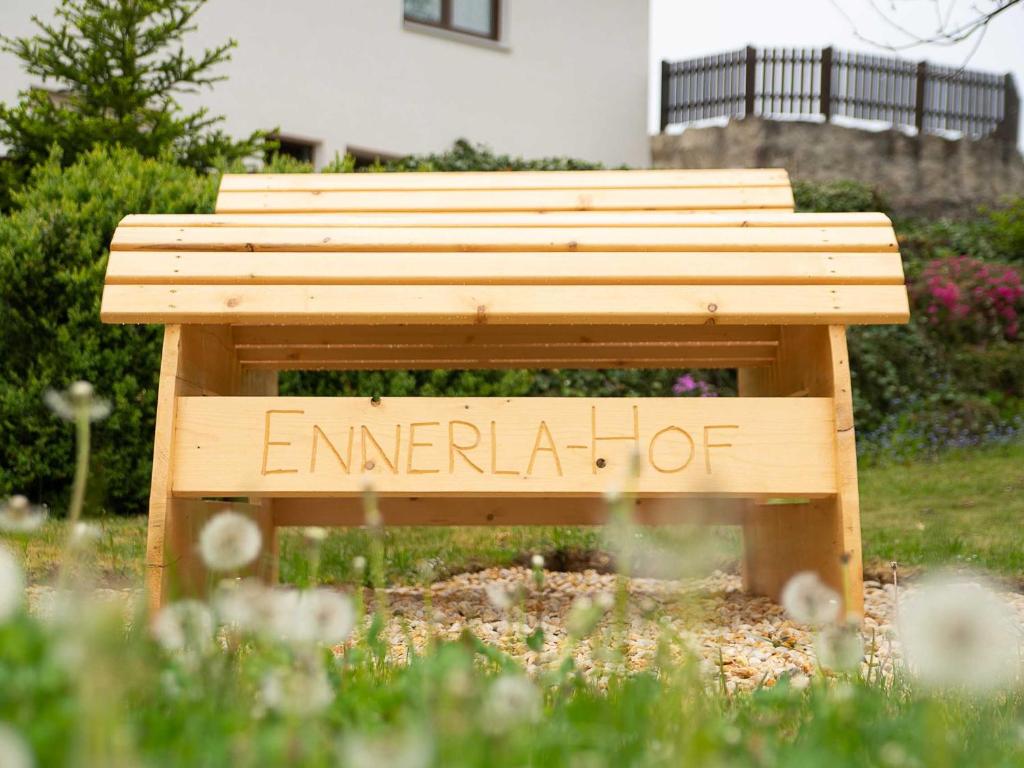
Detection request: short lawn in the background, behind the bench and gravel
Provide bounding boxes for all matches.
[12,444,1024,585]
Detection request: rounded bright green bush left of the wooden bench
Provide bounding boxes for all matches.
[0,150,216,511]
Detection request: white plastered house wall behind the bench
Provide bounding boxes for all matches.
[0,0,649,166]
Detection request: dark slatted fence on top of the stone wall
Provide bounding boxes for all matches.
[662,47,1020,143]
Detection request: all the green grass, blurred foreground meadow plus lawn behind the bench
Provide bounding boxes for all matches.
[0,445,1024,768]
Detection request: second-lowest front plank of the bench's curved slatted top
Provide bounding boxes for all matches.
[106,251,904,285]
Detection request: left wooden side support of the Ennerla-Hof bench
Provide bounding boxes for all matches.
[146,325,276,613]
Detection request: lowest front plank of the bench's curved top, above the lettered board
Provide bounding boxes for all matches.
[100,285,909,326]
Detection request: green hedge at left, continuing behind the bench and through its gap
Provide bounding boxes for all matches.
[0,142,696,514]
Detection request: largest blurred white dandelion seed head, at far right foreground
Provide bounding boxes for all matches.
[899,577,1021,693]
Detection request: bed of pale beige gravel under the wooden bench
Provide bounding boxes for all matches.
[29,567,1024,691]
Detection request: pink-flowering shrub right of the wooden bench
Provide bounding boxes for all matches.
[912,256,1024,342]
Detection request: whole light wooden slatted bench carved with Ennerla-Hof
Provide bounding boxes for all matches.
[101,170,908,610]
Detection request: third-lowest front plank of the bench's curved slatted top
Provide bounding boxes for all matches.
[111,225,898,253]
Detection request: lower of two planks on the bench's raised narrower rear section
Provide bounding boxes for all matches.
[216,185,793,213]
